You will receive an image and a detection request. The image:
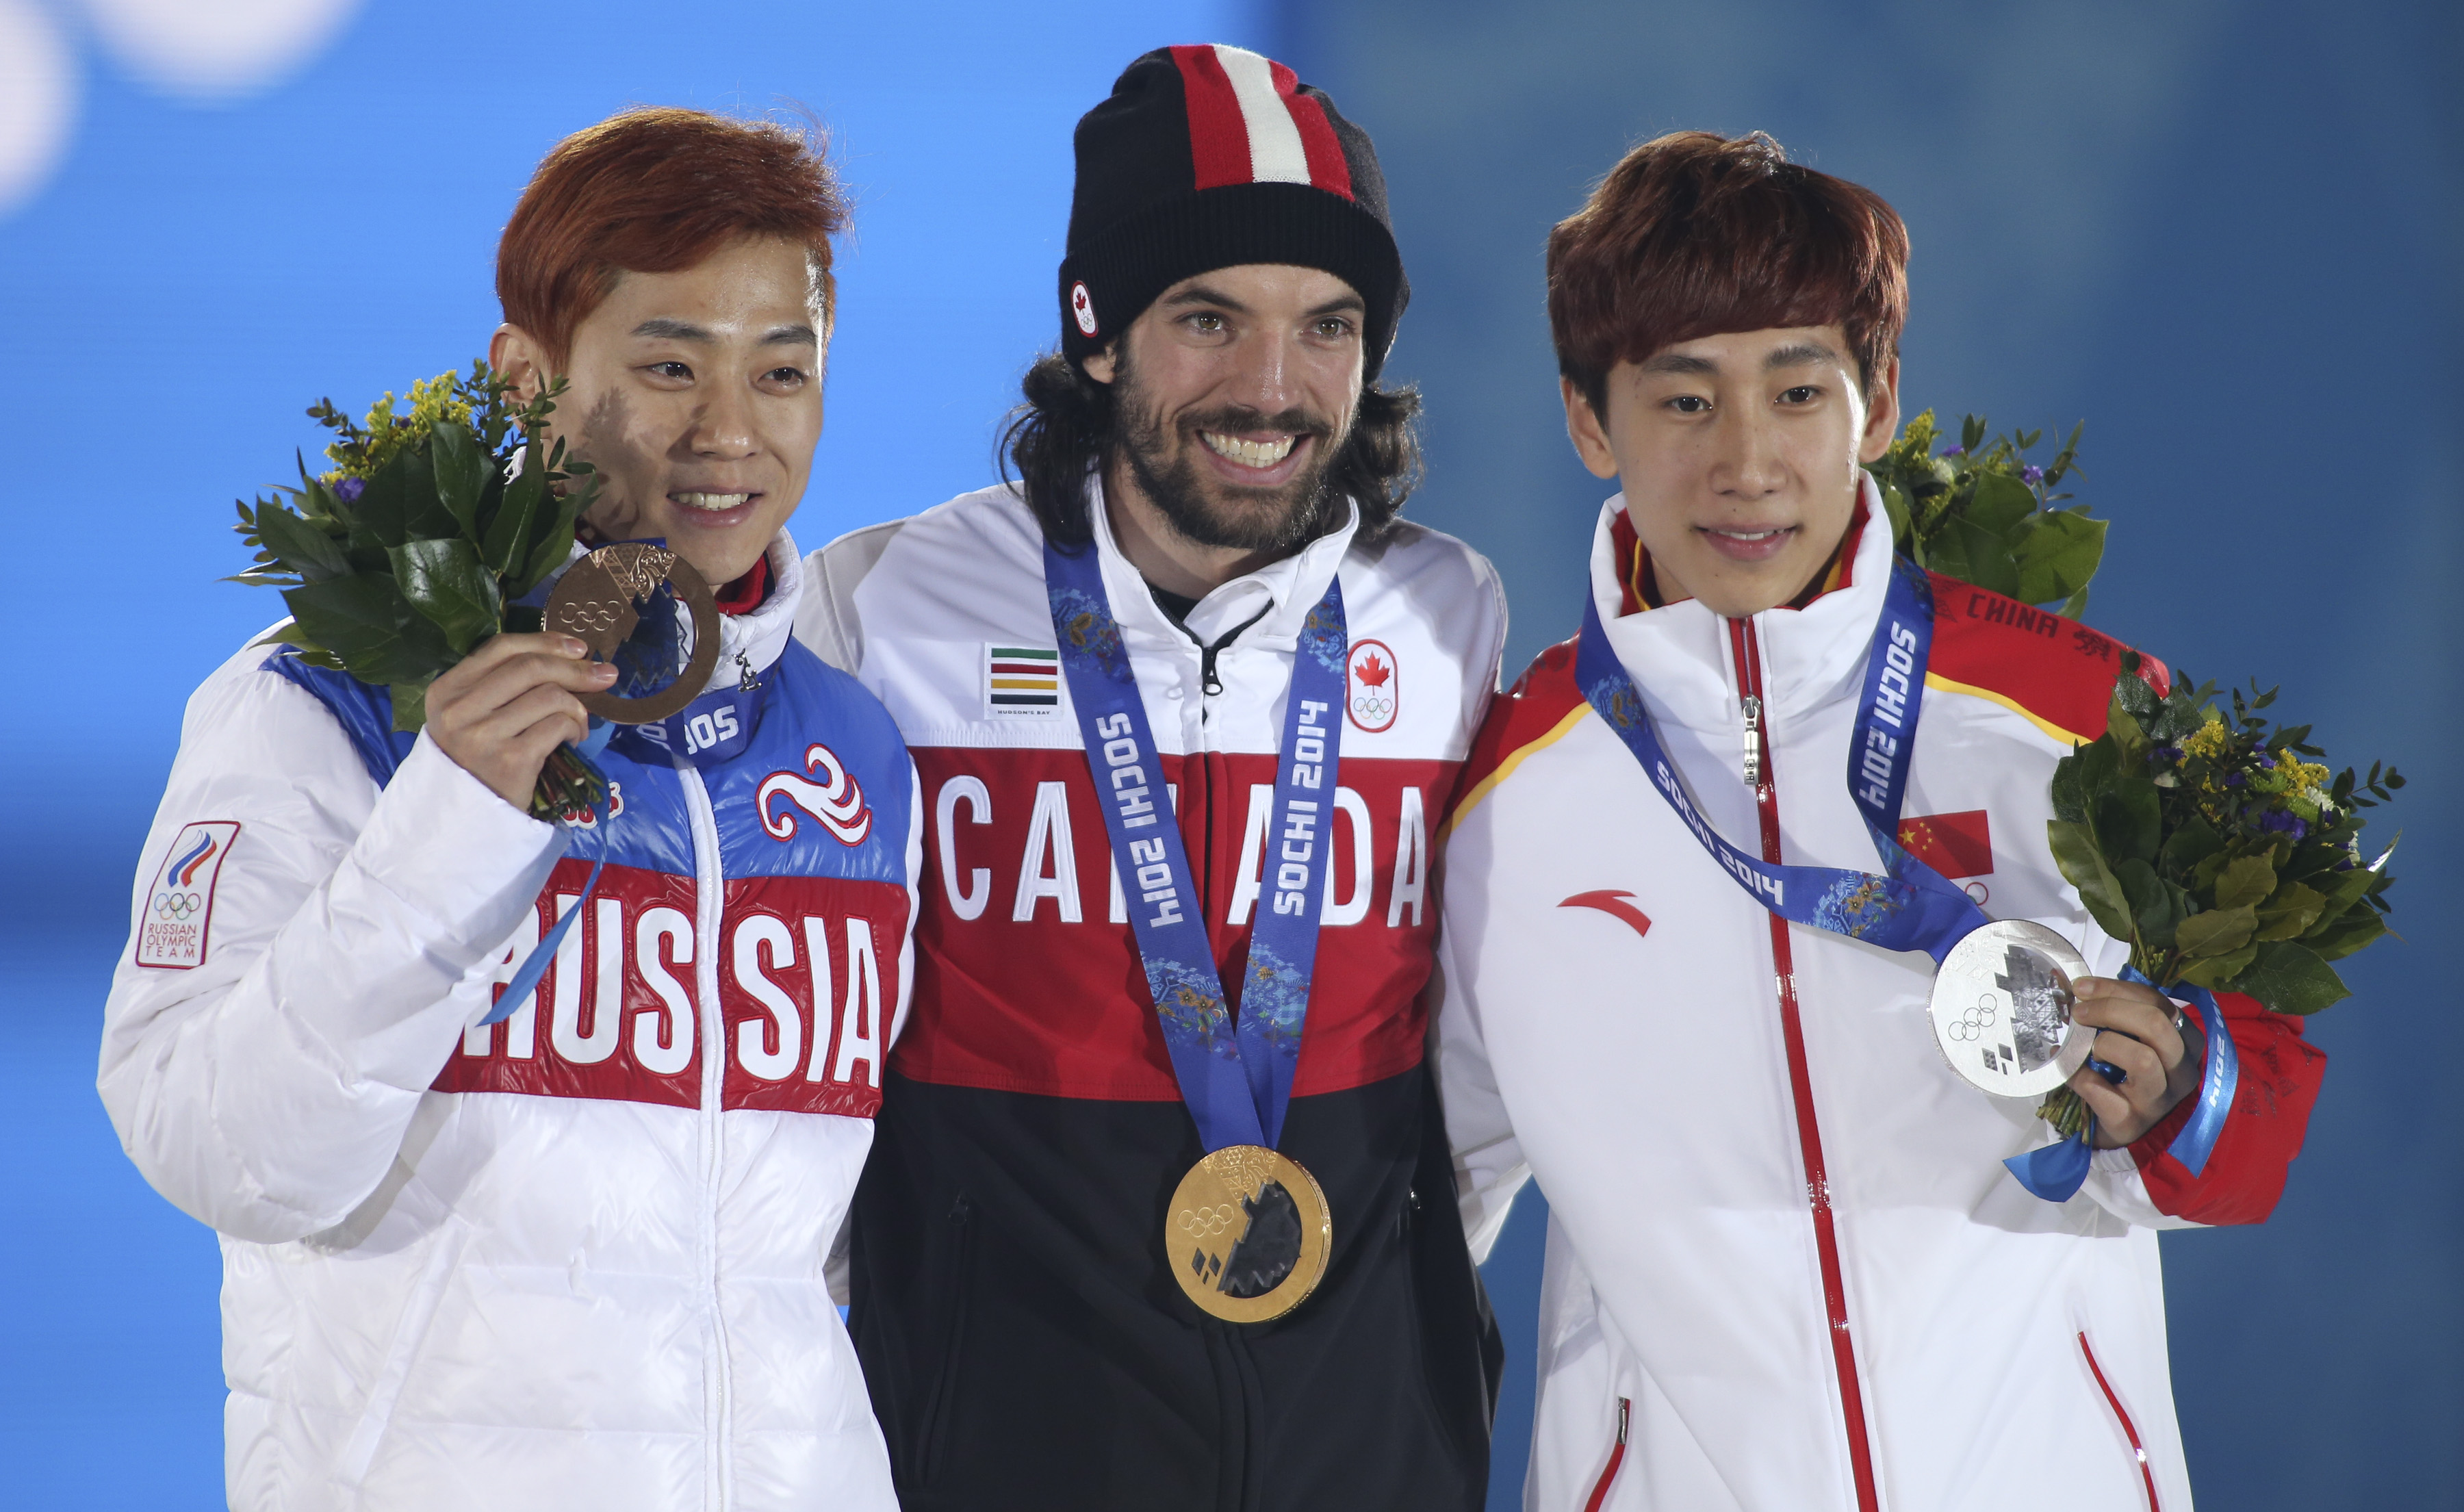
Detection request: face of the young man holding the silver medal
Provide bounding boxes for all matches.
[1562,325,1900,618]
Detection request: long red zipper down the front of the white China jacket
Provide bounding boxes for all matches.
[1728,618,1882,1512]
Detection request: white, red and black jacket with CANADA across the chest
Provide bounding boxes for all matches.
[798,487,1506,1512]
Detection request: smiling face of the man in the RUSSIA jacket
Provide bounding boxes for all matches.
[488,239,828,586]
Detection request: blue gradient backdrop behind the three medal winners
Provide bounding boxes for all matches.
[0,0,2464,1509]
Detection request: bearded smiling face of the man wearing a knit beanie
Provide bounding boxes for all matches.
[1087,264,1363,586]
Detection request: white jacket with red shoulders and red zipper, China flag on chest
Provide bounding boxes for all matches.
[1439,483,2321,1512]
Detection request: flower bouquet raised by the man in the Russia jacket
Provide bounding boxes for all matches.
[229,362,606,817]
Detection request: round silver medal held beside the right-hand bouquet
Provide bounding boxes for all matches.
[1927,919,2097,1099]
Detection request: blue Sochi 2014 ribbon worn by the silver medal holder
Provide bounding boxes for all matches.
[1574,556,2240,1202]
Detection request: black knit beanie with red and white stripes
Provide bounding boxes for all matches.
[1060,44,1412,379]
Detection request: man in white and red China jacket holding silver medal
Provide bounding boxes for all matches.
[1437,133,2321,1512]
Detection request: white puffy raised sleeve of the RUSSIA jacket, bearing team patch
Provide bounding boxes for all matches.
[96,650,564,1244]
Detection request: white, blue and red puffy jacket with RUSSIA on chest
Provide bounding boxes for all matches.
[101,535,921,1512]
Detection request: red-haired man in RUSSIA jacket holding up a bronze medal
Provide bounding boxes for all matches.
[101,111,916,1512]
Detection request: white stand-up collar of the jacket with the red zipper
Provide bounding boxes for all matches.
[1592,475,1890,732]
